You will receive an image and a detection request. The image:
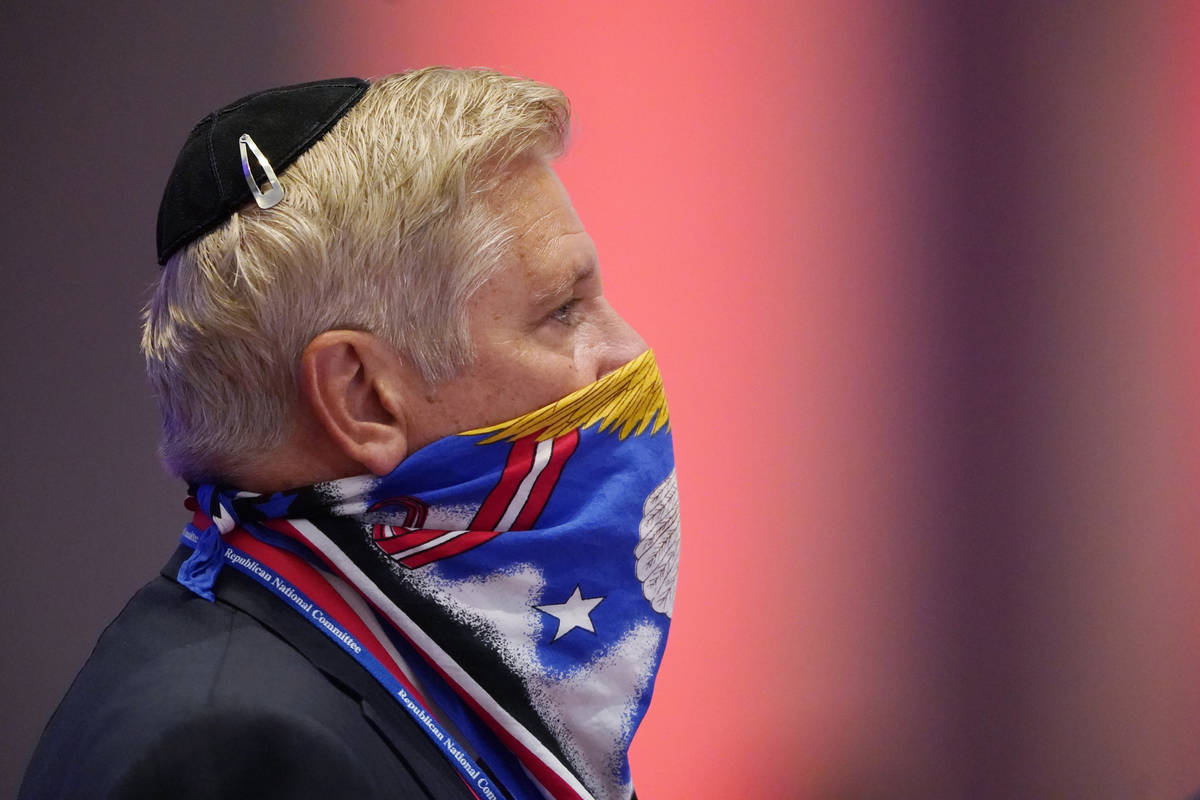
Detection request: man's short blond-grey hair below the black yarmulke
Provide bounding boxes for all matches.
[142,67,570,480]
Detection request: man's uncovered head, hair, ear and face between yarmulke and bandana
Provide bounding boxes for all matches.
[143,68,644,488]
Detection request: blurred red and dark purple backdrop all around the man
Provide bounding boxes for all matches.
[0,0,1200,800]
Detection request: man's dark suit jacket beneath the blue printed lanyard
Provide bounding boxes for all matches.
[18,548,473,800]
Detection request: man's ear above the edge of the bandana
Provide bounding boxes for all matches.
[300,331,408,475]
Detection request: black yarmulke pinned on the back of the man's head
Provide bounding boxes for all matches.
[158,78,371,264]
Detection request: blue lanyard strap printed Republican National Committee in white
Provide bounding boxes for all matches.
[180,525,505,800]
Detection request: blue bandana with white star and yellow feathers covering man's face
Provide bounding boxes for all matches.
[180,351,679,799]
